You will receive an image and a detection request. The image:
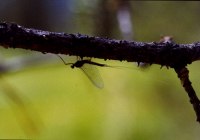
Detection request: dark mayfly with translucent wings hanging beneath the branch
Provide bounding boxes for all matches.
[58,55,111,88]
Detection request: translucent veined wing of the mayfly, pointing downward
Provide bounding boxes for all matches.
[80,63,104,88]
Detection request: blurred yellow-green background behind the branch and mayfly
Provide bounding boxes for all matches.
[0,0,200,140]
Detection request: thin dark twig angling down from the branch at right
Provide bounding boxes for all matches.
[174,67,200,123]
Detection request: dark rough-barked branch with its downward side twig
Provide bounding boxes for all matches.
[0,22,200,122]
